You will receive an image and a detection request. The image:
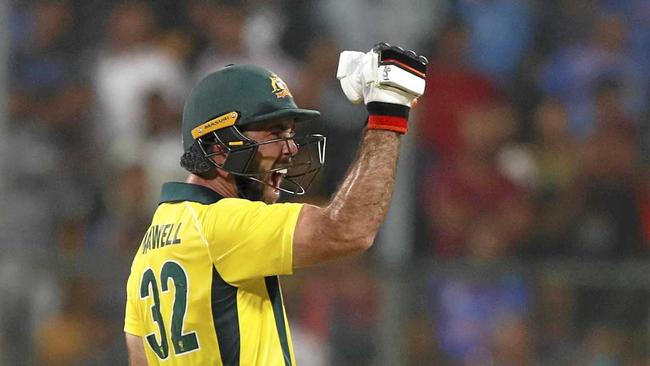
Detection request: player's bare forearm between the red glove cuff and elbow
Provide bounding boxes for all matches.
[324,130,400,245]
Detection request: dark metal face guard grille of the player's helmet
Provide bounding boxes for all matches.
[196,126,326,195]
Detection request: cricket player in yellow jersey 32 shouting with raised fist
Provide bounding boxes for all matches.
[124,43,427,366]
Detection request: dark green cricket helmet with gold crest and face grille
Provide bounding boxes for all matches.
[181,65,325,194]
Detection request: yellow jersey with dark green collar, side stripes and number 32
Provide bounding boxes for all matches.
[124,182,302,366]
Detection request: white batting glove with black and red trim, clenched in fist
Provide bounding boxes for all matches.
[336,43,428,133]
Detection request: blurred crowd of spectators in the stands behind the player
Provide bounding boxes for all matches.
[0,0,650,366]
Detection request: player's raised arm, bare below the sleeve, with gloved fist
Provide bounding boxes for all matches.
[293,44,426,268]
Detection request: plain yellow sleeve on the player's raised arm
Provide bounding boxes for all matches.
[204,199,303,284]
